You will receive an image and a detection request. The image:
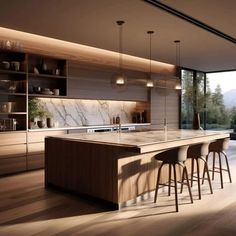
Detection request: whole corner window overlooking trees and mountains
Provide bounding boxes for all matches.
[181,70,236,130]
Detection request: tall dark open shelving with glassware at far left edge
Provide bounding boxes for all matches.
[0,51,27,131]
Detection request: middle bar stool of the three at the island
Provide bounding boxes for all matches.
[181,142,213,199]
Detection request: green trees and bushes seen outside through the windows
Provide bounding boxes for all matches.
[181,70,236,129]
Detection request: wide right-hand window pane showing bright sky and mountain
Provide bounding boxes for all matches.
[206,71,236,130]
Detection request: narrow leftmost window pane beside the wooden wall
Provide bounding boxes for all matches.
[181,70,193,129]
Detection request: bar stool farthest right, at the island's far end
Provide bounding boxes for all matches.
[202,138,232,188]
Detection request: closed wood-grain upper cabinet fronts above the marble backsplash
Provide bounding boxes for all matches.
[68,62,148,101]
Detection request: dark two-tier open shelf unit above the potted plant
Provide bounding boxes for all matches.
[28,54,67,97]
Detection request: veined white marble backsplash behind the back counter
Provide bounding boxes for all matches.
[39,98,136,127]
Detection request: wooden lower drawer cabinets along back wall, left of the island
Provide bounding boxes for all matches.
[0,130,67,176]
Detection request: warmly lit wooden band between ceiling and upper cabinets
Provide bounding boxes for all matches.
[0,27,176,75]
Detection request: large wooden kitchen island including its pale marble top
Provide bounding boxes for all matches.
[45,130,229,208]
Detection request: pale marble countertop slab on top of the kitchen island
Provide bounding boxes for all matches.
[45,129,229,153]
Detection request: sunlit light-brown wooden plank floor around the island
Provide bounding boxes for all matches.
[0,141,236,236]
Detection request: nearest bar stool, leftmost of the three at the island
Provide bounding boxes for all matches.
[154,146,193,212]
